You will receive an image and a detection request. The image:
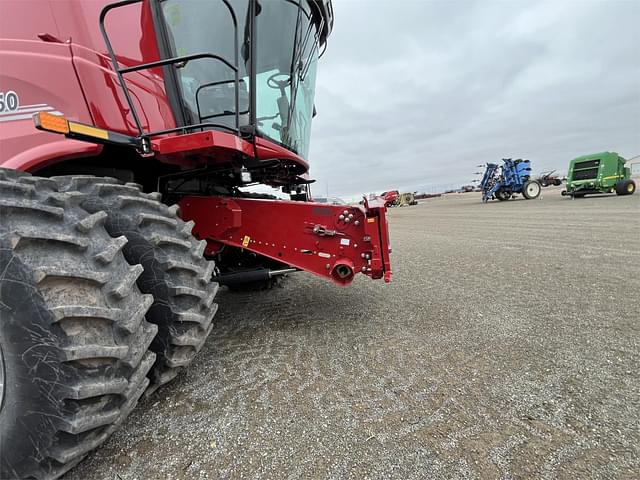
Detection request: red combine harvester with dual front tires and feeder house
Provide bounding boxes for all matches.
[0,0,391,478]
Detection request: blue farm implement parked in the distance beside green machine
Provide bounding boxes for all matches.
[480,158,541,203]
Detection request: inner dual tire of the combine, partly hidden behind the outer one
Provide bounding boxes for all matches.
[54,176,218,393]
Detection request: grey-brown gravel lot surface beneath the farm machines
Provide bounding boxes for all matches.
[66,190,640,480]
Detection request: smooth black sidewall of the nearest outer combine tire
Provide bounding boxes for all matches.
[0,246,64,478]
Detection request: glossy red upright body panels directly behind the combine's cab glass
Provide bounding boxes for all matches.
[65,0,176,139]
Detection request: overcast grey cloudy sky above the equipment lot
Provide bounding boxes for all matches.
[310,0,640,197]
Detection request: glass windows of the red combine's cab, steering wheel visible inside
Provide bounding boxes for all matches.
[161,0,321,158]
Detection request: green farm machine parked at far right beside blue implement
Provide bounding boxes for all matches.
[562,152,636,198]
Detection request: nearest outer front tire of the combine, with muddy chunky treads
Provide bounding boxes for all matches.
[0,169,157,479]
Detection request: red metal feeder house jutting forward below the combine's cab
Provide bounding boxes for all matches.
[180,196,391,285]
